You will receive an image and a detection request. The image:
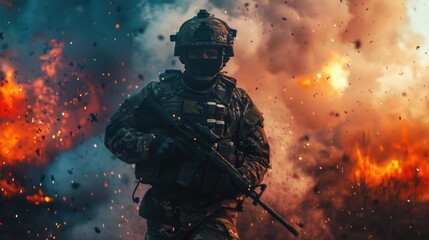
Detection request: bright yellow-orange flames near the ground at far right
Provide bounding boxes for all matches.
[352,144,429,201]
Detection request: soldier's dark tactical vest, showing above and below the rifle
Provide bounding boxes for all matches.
[136,70,239,185]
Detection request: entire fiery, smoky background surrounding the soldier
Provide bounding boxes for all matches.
[0,0,429,239]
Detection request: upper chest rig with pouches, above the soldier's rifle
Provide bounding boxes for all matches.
[160,70,237,169]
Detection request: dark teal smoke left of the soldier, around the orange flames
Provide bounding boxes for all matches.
[0,1,147,239]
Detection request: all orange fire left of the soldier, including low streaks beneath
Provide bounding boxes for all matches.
[0,40,100,204]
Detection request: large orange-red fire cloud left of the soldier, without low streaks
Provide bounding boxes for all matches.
[0,40,99,164]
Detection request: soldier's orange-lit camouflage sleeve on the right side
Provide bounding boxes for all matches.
[238,90,270,187]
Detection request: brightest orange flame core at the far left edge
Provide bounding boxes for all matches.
[0,67,56,163]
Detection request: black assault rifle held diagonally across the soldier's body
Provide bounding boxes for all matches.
[140,97,299,236]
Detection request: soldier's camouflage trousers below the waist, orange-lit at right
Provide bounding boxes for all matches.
[140,191,239,240]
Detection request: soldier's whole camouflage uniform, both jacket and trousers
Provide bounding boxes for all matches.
[105,71,269,239]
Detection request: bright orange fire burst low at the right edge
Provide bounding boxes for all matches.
[352,133,429,202]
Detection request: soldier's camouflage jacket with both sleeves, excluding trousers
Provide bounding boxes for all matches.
[105,70,269,200]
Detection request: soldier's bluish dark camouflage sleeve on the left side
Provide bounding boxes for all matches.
[104,88,155,163]
